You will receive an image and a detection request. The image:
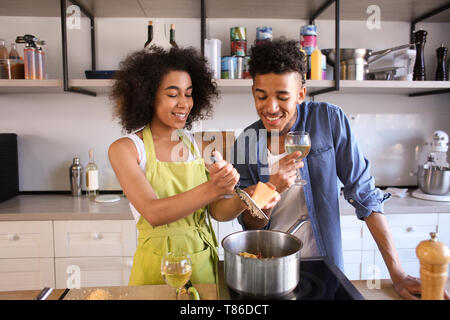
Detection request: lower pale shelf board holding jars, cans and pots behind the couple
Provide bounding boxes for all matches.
[0,79,450,95]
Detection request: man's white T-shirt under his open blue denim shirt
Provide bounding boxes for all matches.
[267,150,320,258]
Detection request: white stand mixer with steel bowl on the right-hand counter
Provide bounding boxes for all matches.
[412,130,450,201]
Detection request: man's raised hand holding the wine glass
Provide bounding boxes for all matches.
[269,151,304,193]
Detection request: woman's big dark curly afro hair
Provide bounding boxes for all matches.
[110,45,218,133]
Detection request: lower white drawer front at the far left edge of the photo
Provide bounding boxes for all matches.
[0,258,55,291]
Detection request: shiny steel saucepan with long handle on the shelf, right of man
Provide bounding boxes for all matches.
[322,44,411,80]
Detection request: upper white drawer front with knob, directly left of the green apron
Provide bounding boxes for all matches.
[54,220,136,257]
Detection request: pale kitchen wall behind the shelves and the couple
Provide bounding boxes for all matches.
[0,16,450,191]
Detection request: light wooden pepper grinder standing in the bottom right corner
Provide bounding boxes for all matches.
[416,232,450,300]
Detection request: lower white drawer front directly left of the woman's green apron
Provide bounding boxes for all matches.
[55,257,133,289]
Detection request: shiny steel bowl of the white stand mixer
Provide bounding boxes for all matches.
[417,165,450,195]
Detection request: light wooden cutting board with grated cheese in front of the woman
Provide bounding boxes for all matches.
[64,284,217,300]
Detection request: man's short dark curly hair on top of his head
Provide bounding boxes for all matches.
[249,38,306,84]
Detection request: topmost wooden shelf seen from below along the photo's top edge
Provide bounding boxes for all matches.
[0,0,450,22]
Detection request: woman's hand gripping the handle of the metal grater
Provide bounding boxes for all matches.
[208,151,240,199]
